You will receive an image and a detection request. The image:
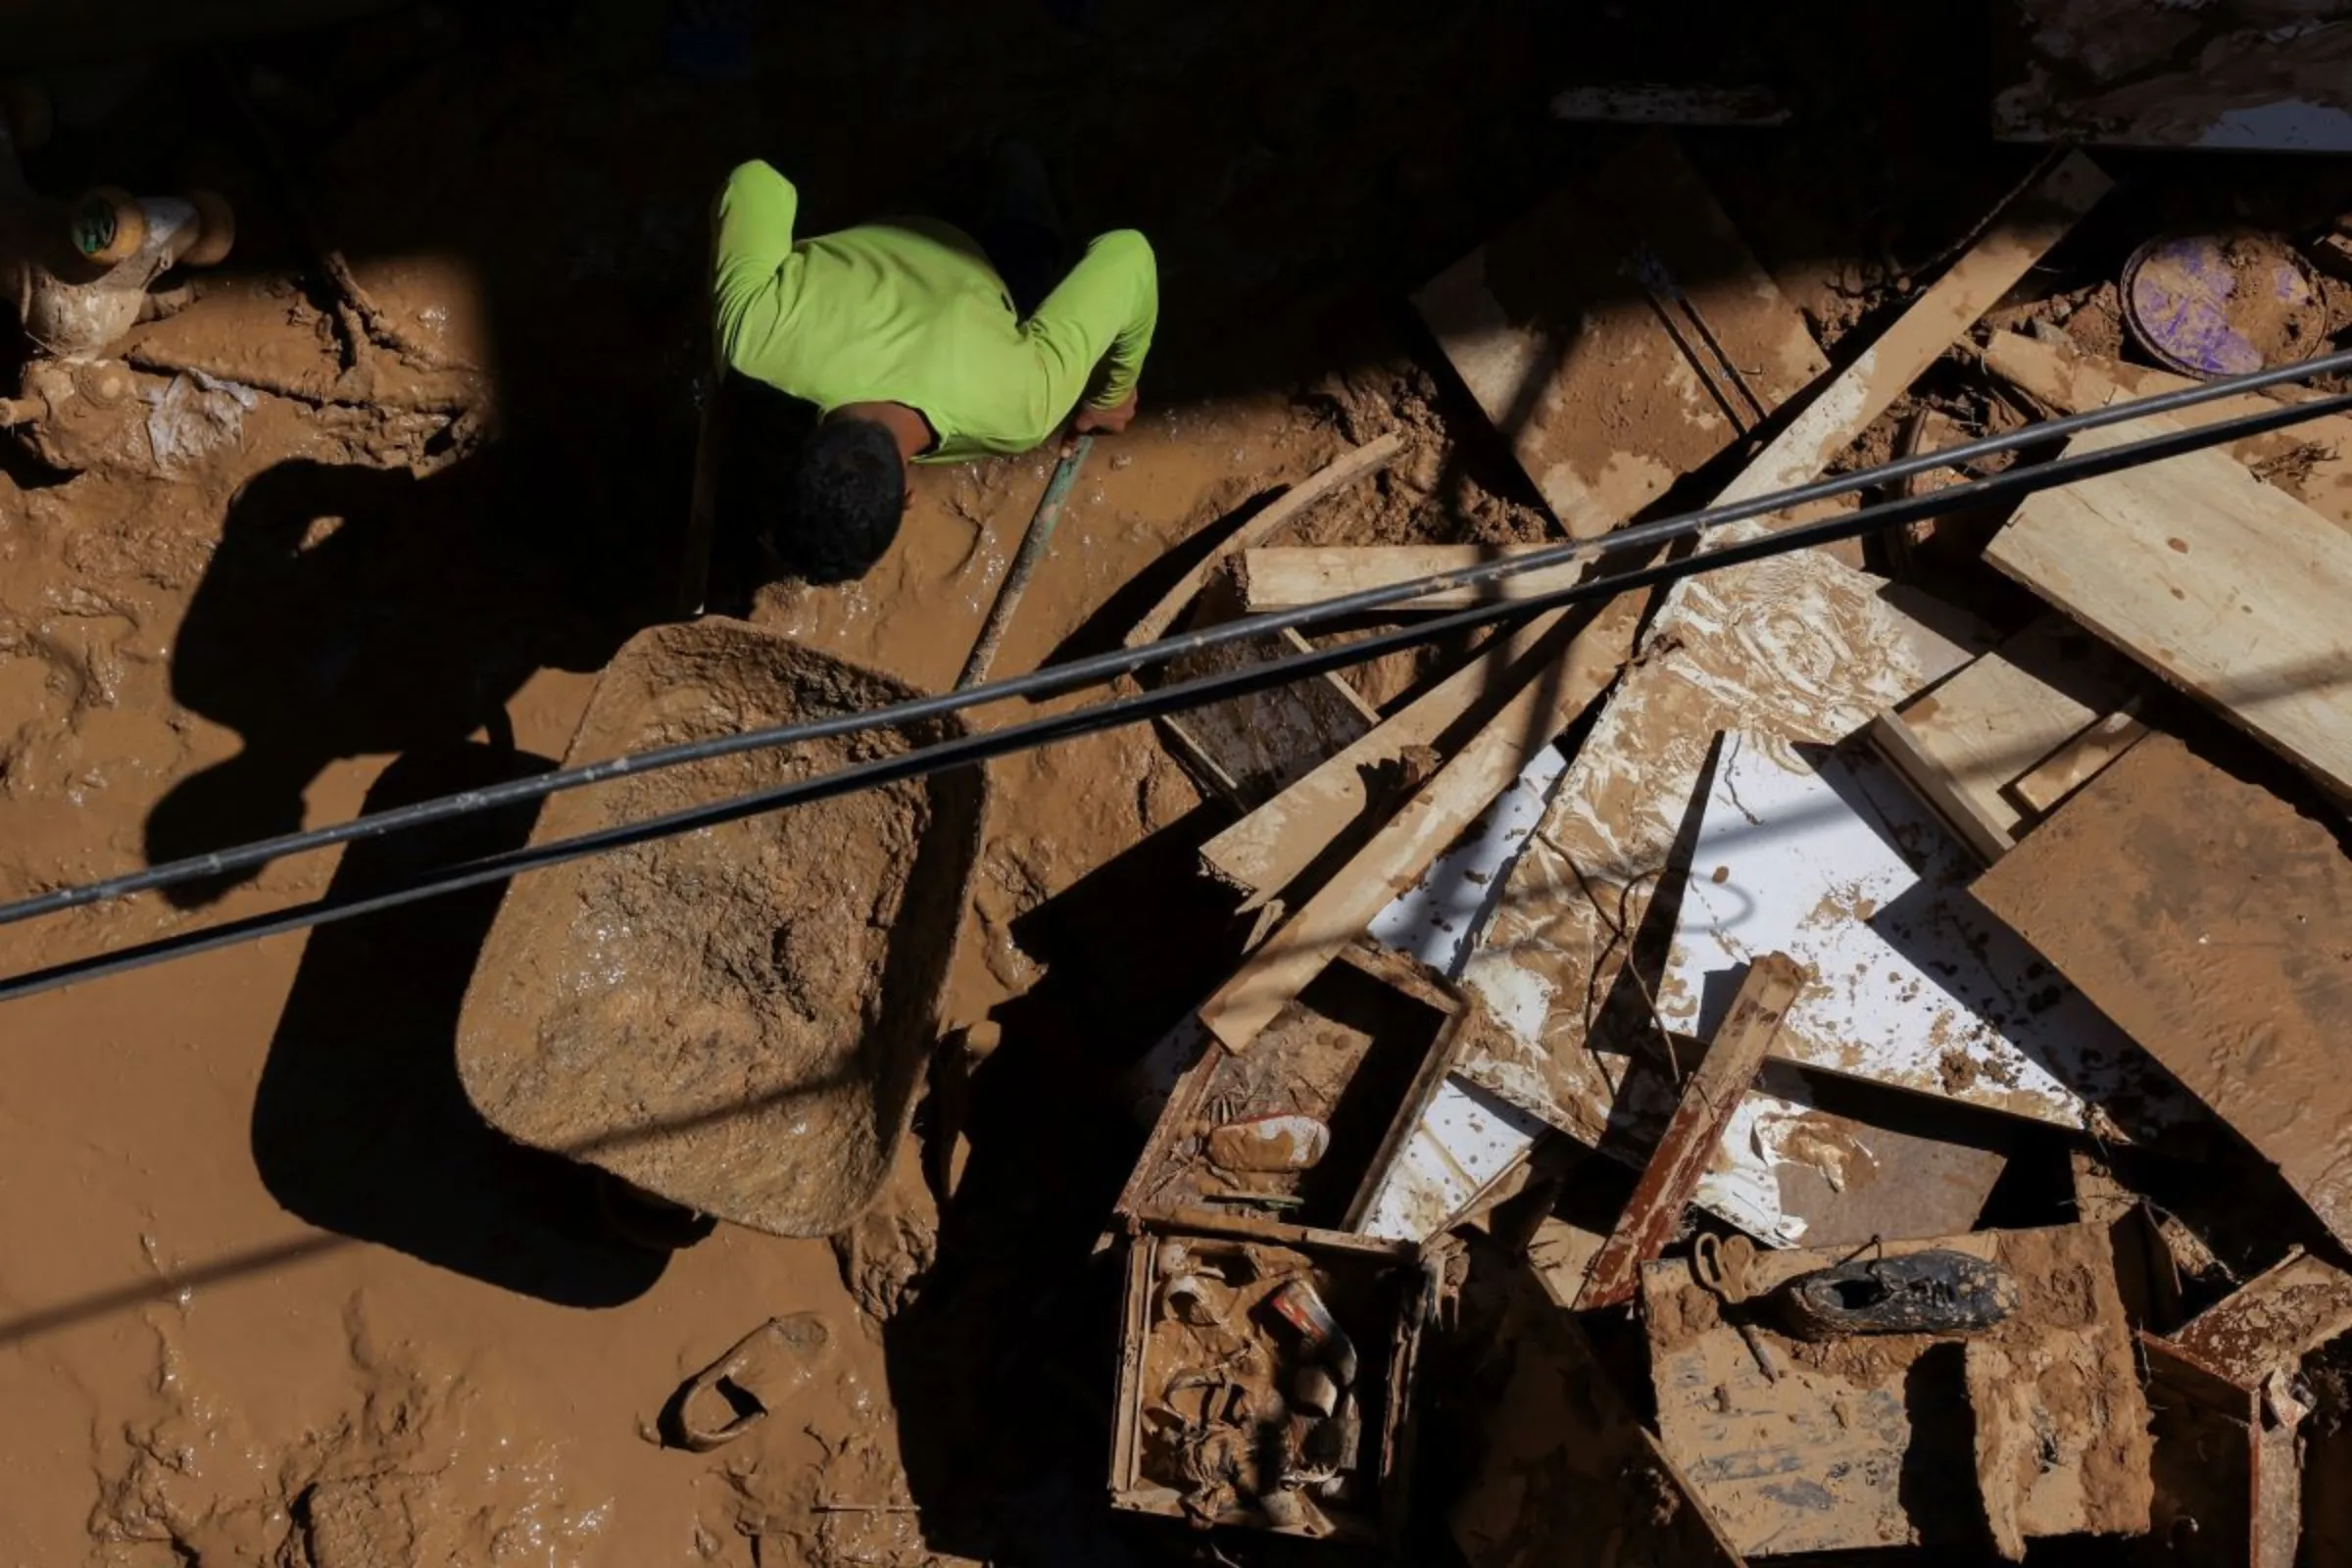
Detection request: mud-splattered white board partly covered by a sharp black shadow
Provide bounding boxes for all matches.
[1658,731,2178,1136]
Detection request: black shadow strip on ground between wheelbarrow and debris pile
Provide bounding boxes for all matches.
[882,807,1235,1568]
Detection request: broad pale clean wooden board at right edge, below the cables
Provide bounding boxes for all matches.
[1985,418,2352,792]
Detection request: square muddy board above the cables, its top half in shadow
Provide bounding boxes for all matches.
[1413,134,1828,538]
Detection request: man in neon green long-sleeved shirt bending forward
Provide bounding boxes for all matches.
[712,163,1159,583]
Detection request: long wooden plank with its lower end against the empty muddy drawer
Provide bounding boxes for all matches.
[1200,597,1640,1051]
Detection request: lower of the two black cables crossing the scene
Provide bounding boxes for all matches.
[0,395,2352,1002]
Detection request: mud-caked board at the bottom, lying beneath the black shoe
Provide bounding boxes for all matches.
[1642,1225,2150,1556]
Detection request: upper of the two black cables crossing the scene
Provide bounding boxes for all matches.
[0,350,2352,926]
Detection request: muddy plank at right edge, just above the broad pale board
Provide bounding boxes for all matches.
[1985,331,2352,529]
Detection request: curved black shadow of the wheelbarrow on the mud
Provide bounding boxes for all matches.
[252,741,668,1307]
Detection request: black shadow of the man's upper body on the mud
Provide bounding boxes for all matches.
[146,454,621,907]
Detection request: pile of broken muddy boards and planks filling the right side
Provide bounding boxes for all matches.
[1115,104,2352,1568]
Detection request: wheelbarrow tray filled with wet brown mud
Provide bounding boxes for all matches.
[459,618,988,1237]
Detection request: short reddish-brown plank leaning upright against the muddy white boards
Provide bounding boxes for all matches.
[1576,953,1804,1312]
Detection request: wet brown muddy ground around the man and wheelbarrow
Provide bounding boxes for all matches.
[0,0,2342,1568]
